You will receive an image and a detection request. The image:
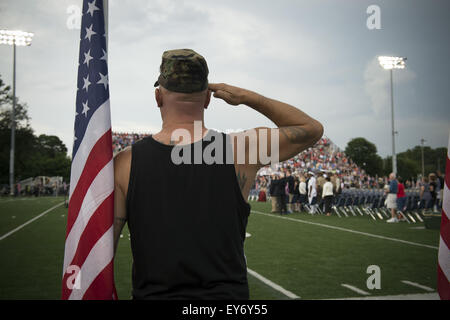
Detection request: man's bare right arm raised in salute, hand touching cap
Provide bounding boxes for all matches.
[209,83,323,198]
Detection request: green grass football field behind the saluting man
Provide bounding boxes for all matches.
[0,197,439,299]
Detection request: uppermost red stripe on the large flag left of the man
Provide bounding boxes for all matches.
[66,129,112,239]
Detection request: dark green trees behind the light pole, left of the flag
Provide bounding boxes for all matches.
[0,76,71,185]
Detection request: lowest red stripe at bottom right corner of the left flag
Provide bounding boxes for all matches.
[83,259,117,300]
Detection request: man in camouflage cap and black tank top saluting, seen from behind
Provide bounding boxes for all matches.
[114,49,323,299]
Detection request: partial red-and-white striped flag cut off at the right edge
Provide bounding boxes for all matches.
[438,132,450,300]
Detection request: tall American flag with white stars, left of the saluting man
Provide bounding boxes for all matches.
[62,0,117,300]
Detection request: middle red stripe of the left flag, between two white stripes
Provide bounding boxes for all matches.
[62,192,114,299]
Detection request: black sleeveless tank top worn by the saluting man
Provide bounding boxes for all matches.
[127,130,250,299]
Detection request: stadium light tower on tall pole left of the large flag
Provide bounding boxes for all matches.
[0,30,33,196]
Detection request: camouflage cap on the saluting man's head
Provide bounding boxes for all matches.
[155,49,209,93]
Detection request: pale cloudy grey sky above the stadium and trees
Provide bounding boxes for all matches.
[0,0,450,156]
